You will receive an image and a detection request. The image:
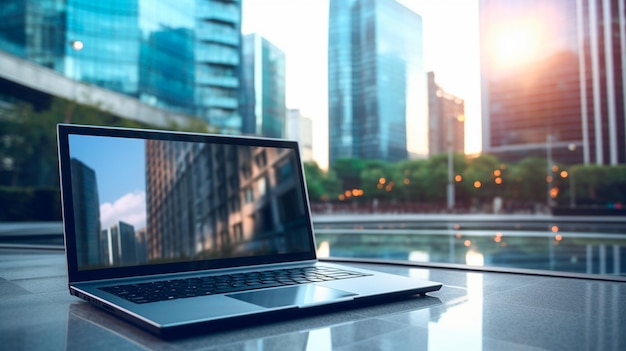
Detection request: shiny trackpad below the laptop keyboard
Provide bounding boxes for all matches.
[226,284,356,308]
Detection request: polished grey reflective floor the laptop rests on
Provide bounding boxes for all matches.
[0,249,626,351]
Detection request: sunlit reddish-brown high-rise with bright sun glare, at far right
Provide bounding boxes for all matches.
[480,0,626,164]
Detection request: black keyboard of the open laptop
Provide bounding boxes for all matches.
[100,267,369,304]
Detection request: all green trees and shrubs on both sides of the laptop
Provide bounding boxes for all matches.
[0,98,626,220]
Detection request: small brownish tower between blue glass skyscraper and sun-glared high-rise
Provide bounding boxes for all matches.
[428,72,465,156]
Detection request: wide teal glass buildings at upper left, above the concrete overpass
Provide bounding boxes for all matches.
[0,0,242,133]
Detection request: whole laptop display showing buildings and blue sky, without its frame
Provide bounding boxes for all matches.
[69,135,310,270]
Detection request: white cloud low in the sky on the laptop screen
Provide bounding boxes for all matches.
[100,191,146,230]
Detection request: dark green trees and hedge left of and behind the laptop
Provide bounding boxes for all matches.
[0,98,211,221]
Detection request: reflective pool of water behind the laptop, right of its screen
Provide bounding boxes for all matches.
[316,223,626,276]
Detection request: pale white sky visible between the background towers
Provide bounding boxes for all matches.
[242,0,481,168]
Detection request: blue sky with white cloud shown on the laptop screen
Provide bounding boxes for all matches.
[70,135,146,229]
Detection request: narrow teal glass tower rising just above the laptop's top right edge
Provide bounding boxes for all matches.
[242,33,287,138]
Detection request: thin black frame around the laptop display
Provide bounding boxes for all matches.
[57,124,316,283]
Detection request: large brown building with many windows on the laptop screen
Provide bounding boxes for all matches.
[146,140,308,262]
